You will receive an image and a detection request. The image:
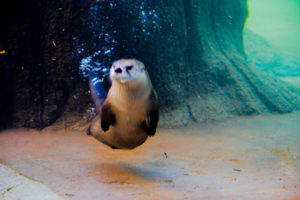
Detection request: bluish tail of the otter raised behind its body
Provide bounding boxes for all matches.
[89,75,107,113]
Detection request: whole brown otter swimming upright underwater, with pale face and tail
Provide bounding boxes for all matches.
[87,59,159,149]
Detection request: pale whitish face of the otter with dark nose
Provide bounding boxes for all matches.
[110,59,147,84]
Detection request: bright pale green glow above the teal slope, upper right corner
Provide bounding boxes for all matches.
[246,0,300,56]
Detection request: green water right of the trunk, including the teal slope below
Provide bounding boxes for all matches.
[244,0,300,87]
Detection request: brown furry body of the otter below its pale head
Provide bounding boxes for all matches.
[89,60,158,149]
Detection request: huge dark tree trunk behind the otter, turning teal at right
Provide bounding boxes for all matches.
[0,0,300,127]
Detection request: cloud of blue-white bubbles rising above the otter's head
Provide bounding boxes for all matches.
[78,0,160,81]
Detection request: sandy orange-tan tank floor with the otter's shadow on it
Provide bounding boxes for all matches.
[0,112,300,200]
